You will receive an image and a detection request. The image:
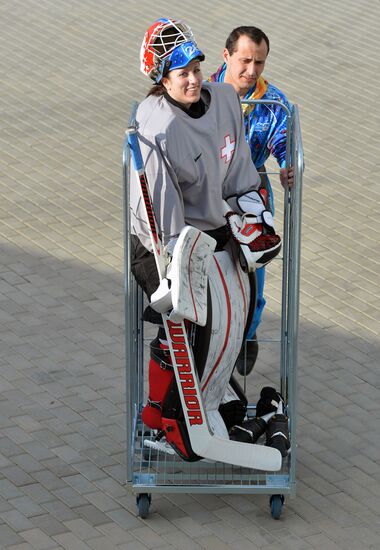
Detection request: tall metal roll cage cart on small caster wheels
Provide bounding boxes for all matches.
[123,100,304,519]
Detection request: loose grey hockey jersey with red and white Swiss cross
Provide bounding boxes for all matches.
[130,82,260,250]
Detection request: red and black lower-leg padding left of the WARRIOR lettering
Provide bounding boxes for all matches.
[141,337,174,430]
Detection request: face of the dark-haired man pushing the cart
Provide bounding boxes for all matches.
[223,35,268,97]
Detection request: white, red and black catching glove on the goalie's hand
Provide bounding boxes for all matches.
[224,191,281,271]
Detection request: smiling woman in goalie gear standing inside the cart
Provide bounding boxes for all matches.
[130,19,280,466]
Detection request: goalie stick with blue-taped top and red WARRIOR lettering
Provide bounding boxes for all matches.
[127,126,282,471]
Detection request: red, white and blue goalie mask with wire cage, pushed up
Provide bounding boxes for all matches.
[140,18,205,84]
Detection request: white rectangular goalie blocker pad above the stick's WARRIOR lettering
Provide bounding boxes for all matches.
[170,226,216,326]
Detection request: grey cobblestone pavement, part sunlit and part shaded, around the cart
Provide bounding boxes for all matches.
[0,0,380,550]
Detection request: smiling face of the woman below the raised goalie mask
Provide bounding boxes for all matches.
[162,59,203,108]
